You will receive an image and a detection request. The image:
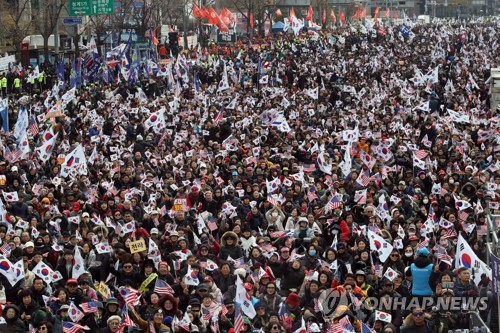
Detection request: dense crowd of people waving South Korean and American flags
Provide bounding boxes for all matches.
[0,16,500,333]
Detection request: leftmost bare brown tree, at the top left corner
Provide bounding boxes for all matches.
[0,0,33,59]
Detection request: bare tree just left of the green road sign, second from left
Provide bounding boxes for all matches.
[32,0,64,62]
